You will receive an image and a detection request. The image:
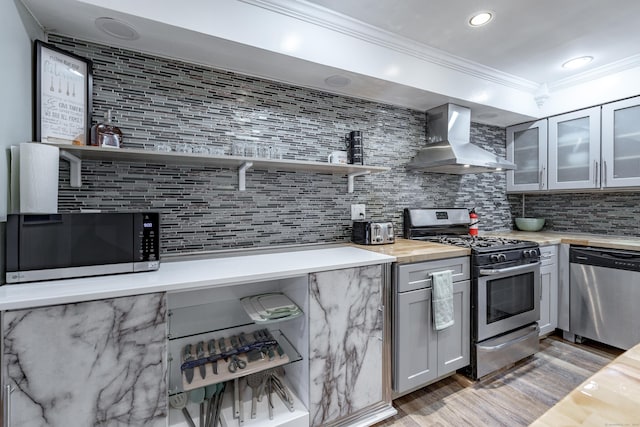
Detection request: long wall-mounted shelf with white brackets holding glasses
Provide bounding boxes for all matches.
[46,143,390,193]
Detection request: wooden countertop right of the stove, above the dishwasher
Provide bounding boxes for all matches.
[486,231,640,251]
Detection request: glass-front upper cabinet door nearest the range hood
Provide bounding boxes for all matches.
[507,119,547,192]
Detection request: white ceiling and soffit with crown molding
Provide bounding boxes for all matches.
[21,0,640,126]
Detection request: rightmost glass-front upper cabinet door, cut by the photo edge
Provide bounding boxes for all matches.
[602,97,640,187]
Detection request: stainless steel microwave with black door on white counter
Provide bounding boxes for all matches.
[5,212,160,283]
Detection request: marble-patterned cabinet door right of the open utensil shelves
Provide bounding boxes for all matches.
[309,265,391,426]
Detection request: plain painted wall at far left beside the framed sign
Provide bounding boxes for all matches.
[0,0,44,283]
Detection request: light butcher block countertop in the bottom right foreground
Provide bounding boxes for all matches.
[531,344,640,427]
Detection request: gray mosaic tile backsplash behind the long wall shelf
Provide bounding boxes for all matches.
[49,35,637,254]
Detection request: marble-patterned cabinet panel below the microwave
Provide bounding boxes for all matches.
[2,293,167,427]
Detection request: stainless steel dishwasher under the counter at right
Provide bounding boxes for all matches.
[569,246,640,350]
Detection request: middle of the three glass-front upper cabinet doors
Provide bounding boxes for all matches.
[548,107,600,190]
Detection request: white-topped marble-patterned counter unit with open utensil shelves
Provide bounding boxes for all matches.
[0,245,395,426]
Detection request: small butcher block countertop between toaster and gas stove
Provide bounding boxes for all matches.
[354,238,471,263]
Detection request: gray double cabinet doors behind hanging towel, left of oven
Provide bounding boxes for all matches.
[395,280,471,392]
